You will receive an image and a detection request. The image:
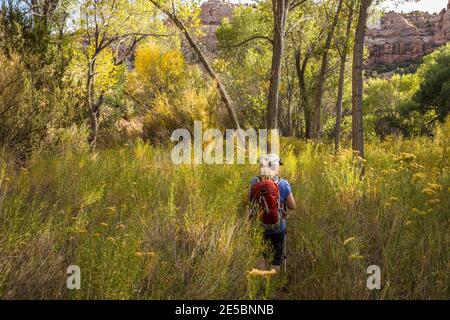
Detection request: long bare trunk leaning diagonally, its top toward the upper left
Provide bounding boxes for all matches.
[150,0,240,129]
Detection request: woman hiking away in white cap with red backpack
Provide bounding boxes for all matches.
[249,154,295,272]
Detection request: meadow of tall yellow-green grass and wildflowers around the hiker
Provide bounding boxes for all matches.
[0,121,450,299]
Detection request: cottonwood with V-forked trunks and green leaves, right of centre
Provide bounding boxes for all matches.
[287,0,343,141]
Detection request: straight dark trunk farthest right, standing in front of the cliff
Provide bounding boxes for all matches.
[352,0,372,158]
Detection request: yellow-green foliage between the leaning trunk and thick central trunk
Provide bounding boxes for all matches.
[215,6,272,128]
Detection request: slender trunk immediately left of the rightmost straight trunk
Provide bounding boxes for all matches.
[335,7,353,152]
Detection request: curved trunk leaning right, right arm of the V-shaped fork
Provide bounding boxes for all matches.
[312,0,343,141]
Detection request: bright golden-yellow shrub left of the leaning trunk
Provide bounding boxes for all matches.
[127,43,217,144]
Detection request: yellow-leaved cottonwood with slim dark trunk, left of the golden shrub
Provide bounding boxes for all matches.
[79,0,167,148]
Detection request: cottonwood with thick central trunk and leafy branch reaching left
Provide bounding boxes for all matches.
[219,0,307,133]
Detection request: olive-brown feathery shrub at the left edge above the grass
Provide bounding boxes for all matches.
[0,53,80,161]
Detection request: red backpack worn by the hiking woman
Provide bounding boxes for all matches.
[250,177,283,230]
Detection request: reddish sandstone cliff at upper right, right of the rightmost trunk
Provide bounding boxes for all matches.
[366,0,450,71]
